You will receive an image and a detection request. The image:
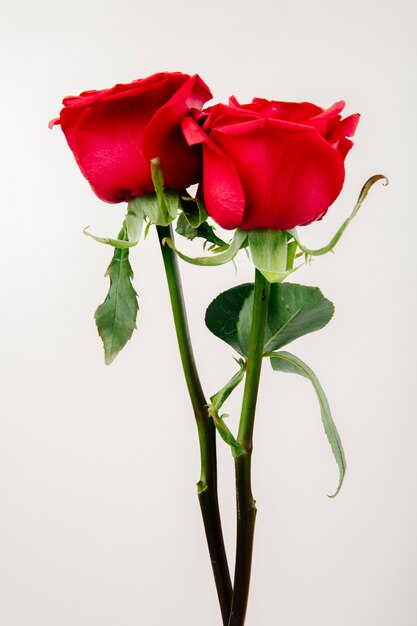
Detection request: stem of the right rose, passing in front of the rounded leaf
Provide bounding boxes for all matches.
[229,270,270,626]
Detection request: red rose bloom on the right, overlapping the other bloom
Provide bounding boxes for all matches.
[183,98,359,230]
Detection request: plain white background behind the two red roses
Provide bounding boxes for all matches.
[0,0,417,626]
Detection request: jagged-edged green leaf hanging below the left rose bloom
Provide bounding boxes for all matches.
[94,243,139,365]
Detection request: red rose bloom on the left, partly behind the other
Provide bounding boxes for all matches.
[50,72,212,202]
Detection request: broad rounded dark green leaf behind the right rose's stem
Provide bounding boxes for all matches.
[206,283,334,356]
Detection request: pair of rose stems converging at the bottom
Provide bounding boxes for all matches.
[157,226,269,626]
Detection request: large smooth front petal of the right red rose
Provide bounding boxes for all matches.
[210,120,344,230]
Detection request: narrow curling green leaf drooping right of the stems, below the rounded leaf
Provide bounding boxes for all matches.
[268,352,346,498]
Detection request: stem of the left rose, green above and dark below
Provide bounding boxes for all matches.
[157,226,232,626]
